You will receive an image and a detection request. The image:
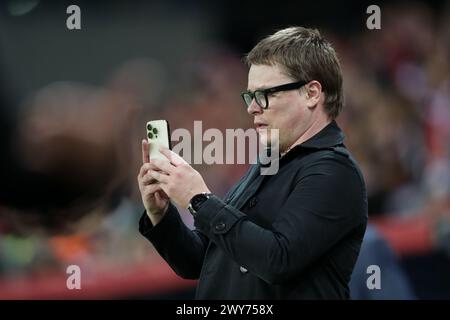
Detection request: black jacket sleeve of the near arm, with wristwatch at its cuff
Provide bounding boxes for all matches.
[195,159,367,284]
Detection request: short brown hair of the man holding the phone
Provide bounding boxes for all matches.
[244,27,343,119]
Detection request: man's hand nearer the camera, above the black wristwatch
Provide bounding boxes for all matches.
[151,147,210,208]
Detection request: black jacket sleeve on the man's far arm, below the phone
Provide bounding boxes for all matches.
[139,203,209,279]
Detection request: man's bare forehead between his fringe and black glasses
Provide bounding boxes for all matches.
[247,64,292,91]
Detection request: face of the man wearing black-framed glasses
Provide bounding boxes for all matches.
[247,65,315,152]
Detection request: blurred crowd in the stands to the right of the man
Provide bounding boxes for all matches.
[338,4,450,218]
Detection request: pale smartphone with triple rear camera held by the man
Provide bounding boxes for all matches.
[146,120,172,160]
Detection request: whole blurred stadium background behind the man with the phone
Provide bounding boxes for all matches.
[0,0,450,299]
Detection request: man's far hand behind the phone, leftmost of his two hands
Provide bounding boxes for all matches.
[137,140,169,225]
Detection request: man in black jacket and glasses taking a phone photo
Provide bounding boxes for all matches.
[138,27,367,299]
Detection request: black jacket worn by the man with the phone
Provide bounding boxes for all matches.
[139,121,367,299]
